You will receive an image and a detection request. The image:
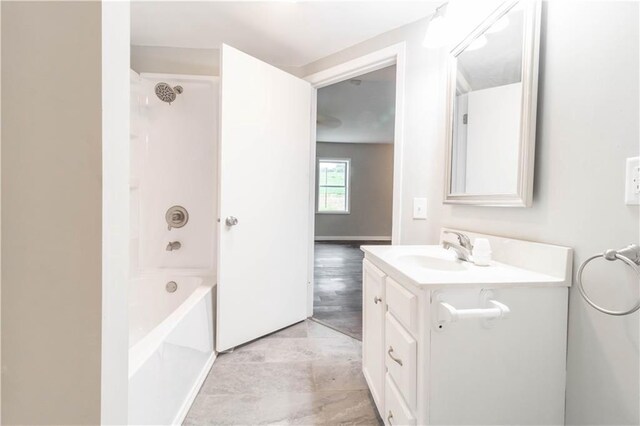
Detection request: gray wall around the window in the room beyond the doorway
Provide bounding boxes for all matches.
[315,142,393,237]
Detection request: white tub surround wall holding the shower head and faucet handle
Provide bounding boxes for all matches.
[131,74,218,276]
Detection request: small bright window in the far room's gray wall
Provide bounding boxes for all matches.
[318,159,351,214]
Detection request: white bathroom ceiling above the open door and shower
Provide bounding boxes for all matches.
[131,0,439,67]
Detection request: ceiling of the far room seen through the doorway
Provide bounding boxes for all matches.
[316,65,396,143]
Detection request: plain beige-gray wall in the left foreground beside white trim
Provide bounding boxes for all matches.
[0,1,102,424]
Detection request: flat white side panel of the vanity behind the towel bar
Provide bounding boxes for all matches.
[429,287,567,425]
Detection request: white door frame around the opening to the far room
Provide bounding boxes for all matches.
[304,42,406,317]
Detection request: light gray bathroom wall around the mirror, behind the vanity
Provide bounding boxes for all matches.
[306,1,640,424]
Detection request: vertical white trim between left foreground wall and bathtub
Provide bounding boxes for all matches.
[100,1,129,424]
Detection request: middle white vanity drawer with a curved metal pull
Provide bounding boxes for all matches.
[384,312,418,410]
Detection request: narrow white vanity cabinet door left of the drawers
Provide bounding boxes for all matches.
[362,259,385,412]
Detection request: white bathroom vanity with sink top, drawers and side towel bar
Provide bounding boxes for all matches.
[362,231,572,425]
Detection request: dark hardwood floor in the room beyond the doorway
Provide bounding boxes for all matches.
[313,241,390,340]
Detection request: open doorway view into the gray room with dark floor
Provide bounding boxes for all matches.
[313,64,397,340]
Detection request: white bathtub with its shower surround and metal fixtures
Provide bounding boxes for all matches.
[129,71,218,424]
